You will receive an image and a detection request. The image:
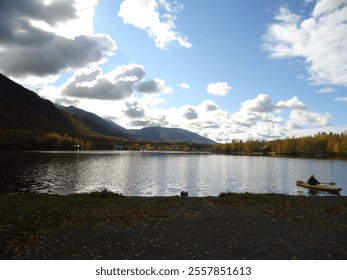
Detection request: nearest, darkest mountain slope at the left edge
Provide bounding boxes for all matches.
[0,73,78,136]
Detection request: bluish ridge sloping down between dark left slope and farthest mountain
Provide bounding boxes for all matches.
[57,105,131,138]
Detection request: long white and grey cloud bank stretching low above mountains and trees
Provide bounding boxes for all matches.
[39,70,338,142]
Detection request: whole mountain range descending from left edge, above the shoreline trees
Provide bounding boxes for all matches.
[0,73,215,144]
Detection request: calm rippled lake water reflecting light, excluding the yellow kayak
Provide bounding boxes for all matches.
[0,151,347,196]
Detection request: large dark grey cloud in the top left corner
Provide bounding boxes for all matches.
[0,0,117,81]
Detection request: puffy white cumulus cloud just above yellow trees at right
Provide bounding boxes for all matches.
[225,94,331,139]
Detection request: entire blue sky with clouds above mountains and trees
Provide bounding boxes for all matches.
[0,0,347,142]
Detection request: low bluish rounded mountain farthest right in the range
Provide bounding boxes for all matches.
[132,126,216,144]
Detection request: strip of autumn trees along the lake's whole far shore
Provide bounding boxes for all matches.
[0,129,347,157]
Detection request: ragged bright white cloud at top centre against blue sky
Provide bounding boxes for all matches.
[118,0,192,49]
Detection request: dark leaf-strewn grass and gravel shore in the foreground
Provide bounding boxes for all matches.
[0,192,347,259]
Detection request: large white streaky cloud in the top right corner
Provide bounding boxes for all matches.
[264,0,347,86]
